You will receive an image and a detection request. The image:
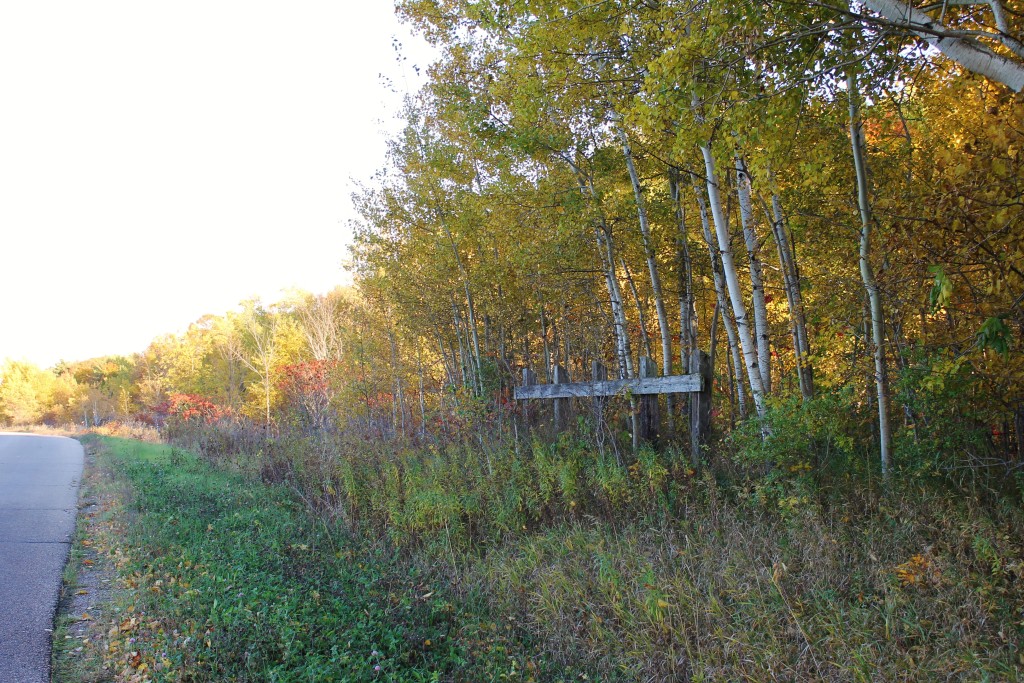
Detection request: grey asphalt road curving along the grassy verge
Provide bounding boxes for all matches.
[0,432,82,683]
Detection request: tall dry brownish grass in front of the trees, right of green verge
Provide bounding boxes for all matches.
[466,484,1024,681]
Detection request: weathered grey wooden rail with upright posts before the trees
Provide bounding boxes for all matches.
[515,351,712,463]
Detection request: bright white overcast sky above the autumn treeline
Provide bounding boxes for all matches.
[0,0,432,367]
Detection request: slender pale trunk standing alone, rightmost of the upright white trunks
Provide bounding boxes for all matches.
[846,72,892,479]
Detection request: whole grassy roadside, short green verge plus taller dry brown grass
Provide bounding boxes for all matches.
[54,439,1024,681]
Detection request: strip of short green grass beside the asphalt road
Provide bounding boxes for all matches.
[100,438,557,681]
